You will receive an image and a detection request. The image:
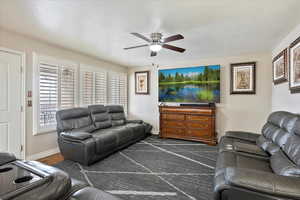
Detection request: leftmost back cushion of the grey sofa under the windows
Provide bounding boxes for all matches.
[56,108,95,133]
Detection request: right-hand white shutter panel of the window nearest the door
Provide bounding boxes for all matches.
[60,67,76,109]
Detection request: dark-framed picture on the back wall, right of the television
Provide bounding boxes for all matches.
[230,62,256,94]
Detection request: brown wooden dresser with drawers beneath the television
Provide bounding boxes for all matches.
[159,106,216,145]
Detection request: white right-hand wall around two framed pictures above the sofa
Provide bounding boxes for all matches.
[272,24,300,113]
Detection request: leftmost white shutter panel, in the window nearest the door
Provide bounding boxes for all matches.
[39,64,59,128]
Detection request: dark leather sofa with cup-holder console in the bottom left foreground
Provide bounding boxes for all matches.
[0,153,120,200]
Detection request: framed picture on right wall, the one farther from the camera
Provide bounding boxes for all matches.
[273,49,288,84]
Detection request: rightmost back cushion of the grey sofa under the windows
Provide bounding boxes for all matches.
[106,105,126,126]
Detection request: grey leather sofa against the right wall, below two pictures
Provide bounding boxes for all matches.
[214,111,300,200]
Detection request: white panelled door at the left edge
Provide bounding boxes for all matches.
[0,50,22,158]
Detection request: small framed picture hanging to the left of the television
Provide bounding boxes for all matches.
[135,71,149,94]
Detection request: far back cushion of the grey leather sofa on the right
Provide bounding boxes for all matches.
[257,111,298,154]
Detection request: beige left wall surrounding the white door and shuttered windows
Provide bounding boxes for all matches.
[0,29,128,158]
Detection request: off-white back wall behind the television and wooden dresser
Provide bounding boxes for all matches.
[129,53,272,137]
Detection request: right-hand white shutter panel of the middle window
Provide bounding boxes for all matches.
[94,72,107,104]
